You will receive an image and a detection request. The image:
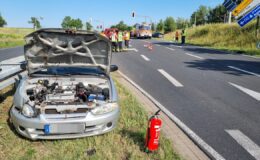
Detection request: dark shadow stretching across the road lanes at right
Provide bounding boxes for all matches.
[184,59,260,76]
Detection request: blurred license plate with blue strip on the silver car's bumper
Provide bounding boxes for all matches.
[44,123,85,134]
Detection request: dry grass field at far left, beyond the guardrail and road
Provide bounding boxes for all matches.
[0,28,33,48]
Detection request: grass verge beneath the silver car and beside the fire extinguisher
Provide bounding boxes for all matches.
[0,79,180,160]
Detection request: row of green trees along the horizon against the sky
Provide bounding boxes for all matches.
[0,5,228,33]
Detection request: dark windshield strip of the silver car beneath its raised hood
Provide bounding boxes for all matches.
[34,67,105,75]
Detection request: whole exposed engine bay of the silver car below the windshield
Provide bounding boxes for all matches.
[26,79,110,112]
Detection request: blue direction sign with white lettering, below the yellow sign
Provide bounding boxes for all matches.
[238,5,260,27]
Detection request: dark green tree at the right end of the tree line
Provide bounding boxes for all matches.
[208,5,227,23]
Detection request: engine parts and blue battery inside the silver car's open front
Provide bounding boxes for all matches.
[26,79,109,105]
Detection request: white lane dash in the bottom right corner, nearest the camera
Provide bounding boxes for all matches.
[226,130,260,160]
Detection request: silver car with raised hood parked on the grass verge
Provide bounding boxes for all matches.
[10,29,119,140]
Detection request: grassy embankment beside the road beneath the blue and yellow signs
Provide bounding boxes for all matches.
[165,21,260,56]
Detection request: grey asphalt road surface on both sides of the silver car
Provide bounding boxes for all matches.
[0,40,260,160]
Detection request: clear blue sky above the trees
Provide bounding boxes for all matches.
[0,0,224,28]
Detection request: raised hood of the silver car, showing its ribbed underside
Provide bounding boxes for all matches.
[24,29,111,74]
